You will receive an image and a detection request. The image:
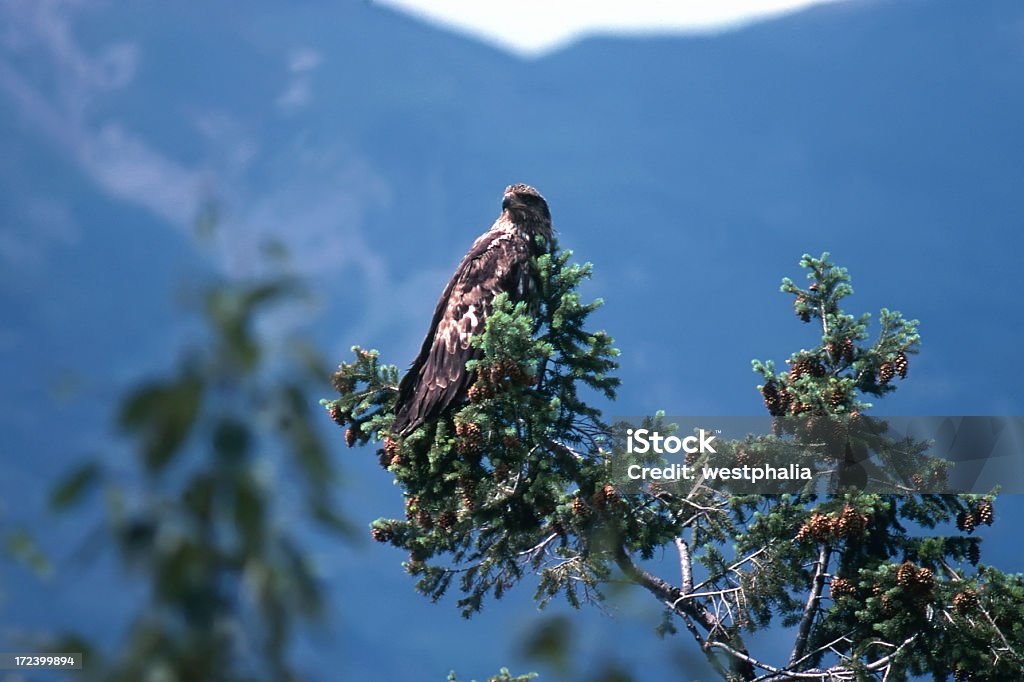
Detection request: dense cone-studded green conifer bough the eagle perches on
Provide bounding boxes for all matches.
[325,240,618,615]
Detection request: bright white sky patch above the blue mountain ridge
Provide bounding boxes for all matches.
[377,0,853,54]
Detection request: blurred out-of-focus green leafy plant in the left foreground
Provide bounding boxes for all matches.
[50,261,349,682]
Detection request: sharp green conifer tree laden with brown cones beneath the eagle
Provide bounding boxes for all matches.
[324,245,1024,681]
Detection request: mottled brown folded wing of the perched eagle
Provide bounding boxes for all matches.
[391,228,531,435]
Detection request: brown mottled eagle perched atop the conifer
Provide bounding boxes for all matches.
[391,184,551,436]
